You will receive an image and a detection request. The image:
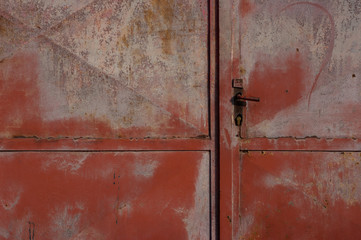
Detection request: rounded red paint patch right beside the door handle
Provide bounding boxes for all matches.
[246,53,308,126]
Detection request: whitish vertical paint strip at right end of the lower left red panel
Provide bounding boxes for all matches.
[183,154,210,240]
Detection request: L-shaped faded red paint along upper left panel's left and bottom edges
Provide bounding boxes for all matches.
[0,52,204,138]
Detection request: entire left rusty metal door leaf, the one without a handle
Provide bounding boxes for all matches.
[0,0,216,240]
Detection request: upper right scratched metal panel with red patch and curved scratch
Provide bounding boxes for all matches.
[240,0,361,138]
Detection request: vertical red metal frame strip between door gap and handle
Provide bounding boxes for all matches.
[218,0,240,239]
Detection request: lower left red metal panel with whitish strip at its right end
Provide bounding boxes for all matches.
[0,152,210,240]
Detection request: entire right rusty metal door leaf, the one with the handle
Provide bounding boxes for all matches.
[220,0,361,240]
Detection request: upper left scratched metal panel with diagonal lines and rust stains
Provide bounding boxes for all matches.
[0,0,209,138]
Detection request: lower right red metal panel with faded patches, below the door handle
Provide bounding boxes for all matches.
[239,152,361,239]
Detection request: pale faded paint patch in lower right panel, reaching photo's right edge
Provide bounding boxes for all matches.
[263,153,361,205]
